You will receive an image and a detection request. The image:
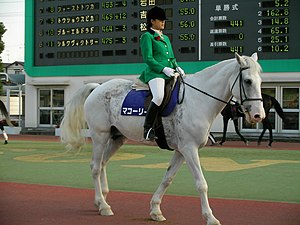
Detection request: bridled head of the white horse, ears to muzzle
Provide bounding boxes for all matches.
[231,53,265,123]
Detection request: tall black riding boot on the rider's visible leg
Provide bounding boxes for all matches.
[144,101,160,141]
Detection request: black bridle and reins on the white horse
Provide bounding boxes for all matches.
[178,64,263,112]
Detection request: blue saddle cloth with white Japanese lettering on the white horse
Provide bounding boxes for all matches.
[121,82,179,117]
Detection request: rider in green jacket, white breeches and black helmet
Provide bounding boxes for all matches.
[139,6,184,140]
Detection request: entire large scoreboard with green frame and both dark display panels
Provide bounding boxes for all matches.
[25,0,300,76]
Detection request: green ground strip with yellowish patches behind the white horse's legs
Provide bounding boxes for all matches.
[0,141,300,203]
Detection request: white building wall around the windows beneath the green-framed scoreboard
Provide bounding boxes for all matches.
[25,72,300,135]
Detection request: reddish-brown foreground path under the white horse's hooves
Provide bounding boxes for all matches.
[0,182,300,225]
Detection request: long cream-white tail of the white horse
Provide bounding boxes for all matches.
[60,83,99,150]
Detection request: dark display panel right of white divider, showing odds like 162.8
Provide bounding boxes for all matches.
[201,0,300,60]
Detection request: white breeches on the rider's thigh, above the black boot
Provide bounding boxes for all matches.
[148,78,165,106]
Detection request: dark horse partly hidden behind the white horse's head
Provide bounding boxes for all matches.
[219,94,287,147]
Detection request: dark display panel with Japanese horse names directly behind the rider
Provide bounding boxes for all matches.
[34,0,200,66]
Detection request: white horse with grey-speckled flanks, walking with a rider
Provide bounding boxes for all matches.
[61,53,265,225]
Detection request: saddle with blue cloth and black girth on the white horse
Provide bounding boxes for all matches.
[121,77,179,150]
